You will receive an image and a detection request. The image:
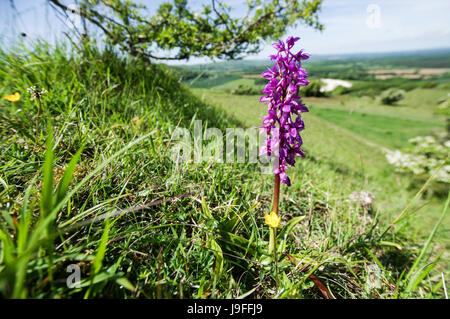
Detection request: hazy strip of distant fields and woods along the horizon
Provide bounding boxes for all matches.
[177,49,450,88]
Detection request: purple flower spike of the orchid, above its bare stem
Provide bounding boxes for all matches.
[260,37,309,186]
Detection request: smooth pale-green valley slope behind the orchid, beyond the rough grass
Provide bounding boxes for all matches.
[194,89,450,249]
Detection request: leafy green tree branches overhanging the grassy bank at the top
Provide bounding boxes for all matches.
[48,0,323,60]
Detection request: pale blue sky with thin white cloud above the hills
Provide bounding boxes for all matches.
[0,0,450,62]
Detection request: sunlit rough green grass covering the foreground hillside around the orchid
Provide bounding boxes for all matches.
[0,46,446,298]
